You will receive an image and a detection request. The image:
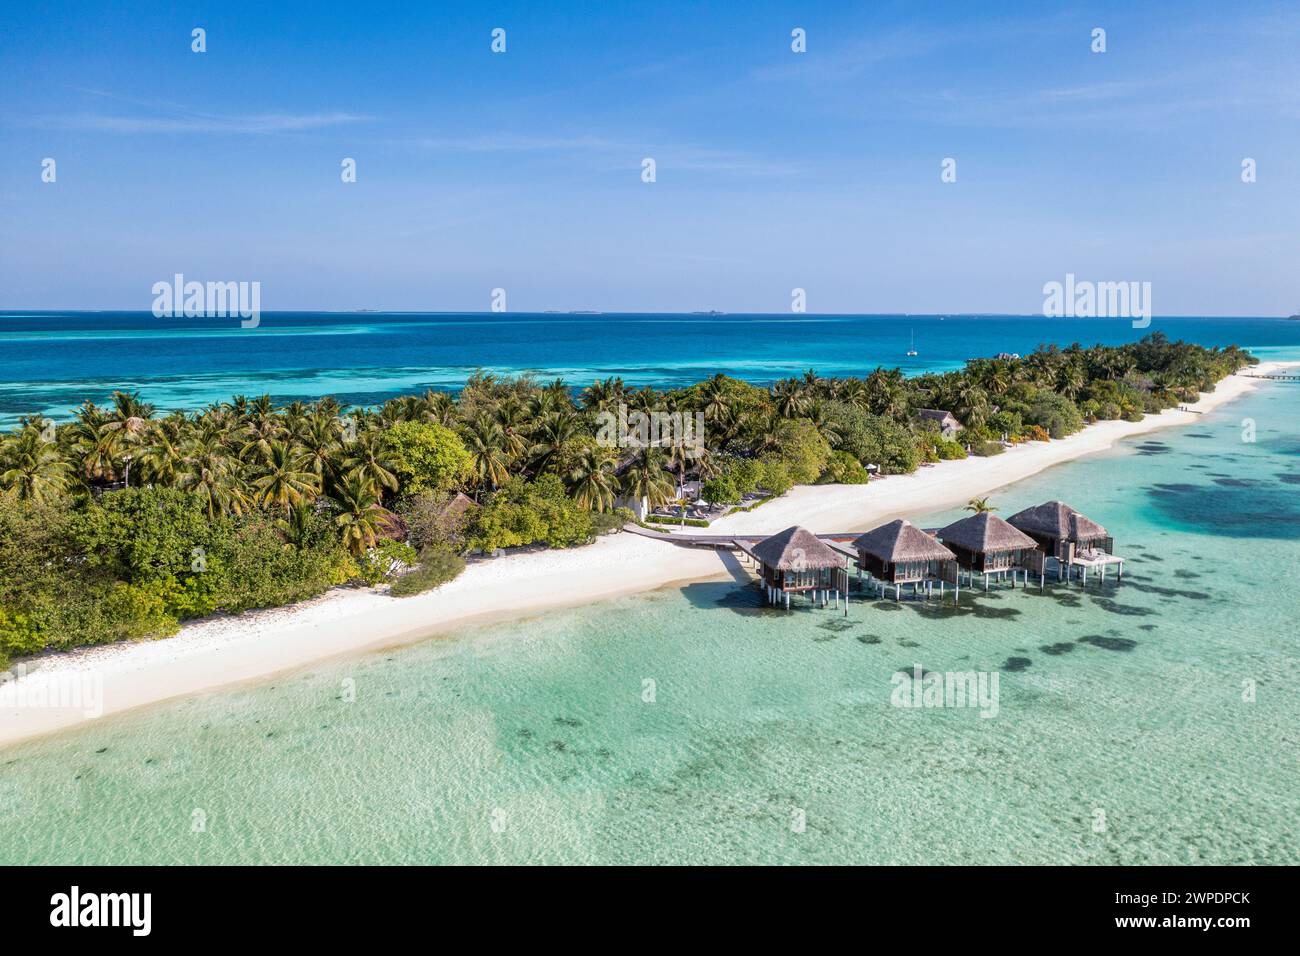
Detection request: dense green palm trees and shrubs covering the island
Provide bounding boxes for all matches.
[0,334,1255,656]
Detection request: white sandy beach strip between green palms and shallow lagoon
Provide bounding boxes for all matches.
[0,362,1300,747]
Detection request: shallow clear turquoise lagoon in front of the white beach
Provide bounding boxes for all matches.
[0,384,1300,864]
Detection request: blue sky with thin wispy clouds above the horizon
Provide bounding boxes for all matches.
[0,0,1300,315]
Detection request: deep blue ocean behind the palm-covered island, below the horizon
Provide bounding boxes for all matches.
[0,311,1300,424]
